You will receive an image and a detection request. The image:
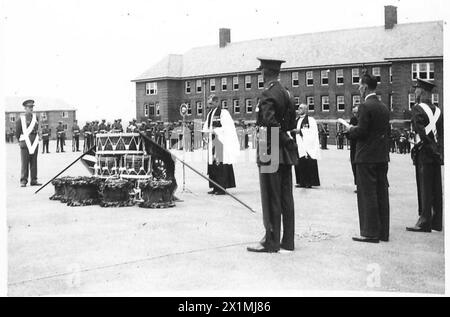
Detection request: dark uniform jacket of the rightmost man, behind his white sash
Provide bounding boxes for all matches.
[411,103,444,164]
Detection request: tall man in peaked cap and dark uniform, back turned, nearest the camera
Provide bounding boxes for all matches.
[247,58,297,252]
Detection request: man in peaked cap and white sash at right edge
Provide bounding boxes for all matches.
[406,78,444,232]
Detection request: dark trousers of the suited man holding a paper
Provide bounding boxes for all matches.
[356,163,389,240]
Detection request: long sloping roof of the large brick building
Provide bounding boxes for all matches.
[133,21,443,81]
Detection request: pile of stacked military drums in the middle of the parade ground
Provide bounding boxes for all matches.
[50,133,176,208]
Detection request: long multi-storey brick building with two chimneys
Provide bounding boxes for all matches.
[133,6,443,136]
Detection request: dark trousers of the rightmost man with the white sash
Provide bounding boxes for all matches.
[416,163,442,231]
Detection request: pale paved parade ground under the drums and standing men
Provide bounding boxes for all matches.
[6,142,445,296]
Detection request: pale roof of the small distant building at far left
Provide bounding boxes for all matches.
[3,96,77,112]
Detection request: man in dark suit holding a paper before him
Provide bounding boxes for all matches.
[348,73,390,243]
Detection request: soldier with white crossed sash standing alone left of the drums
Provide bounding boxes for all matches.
[16,100,42,187]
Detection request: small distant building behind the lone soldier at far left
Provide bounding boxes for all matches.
[4,97,76,140]
